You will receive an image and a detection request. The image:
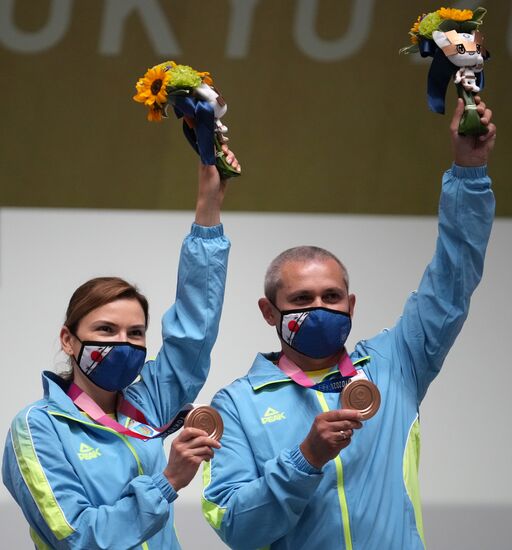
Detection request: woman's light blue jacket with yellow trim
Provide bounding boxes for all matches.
[2,224,229,550]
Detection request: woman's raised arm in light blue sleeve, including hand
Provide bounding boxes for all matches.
[126,149,238,425]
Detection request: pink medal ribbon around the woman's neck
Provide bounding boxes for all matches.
[67,383,193,441]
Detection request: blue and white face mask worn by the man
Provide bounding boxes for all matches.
[277,307,352,359]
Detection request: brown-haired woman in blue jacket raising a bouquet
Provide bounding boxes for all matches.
[3,149,238,550]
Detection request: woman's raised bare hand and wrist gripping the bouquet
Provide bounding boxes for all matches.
[195,145,241,227]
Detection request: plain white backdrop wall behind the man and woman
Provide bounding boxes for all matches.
[0,208,512,548]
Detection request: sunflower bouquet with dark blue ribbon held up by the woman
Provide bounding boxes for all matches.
[133,61,240,179]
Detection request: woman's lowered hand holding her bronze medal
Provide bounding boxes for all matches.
[164,430,221,491]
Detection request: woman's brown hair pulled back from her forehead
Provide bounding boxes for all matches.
[64,277,149,334]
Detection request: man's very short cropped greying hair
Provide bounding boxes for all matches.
[264,246,348,304]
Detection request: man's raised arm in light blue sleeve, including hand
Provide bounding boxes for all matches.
[391,97,496,402]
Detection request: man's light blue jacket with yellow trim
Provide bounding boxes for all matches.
[203,166,494,550]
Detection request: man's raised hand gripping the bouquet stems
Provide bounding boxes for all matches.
[450,96,496,166]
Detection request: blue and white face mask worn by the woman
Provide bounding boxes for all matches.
[75,339,146,391]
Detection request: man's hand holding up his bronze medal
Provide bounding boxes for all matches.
[300,409,363,468]
